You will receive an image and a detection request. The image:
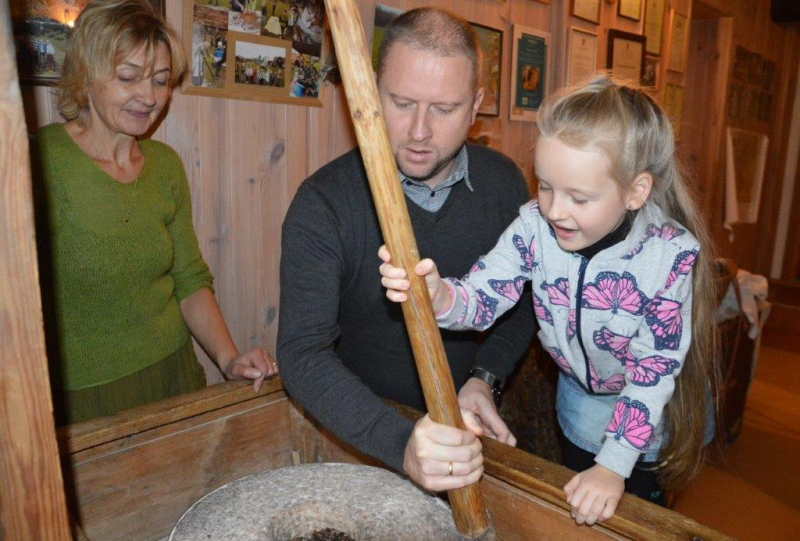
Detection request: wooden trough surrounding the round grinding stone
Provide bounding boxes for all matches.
[58,377,727,540]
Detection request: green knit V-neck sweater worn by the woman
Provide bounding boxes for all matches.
[37,124,212,390]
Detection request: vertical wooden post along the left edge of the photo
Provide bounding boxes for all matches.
[0,2,70,540]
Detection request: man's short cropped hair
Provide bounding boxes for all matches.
[378,7,481,89]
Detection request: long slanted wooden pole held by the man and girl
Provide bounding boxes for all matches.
[325,0,489,538]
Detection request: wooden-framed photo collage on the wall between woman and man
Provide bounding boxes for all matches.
[183,0,329,107]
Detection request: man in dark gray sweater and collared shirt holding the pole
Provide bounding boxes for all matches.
[278,8,534,491]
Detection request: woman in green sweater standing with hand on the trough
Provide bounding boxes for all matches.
[37,0,277,422]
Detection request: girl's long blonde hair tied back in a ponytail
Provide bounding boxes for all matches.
[537,74,719,490]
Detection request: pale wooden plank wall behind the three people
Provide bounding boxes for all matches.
[23,0,800,382]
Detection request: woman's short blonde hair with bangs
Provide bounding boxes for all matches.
[58,0,186,124]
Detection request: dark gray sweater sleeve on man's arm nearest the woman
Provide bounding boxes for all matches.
[278,183,414,471]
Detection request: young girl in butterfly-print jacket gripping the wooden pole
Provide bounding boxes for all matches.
[379,76,716,524]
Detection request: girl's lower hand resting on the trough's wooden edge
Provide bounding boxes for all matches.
[564,464,625,526]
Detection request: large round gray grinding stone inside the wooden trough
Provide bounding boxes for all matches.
[169,464,461,541]
